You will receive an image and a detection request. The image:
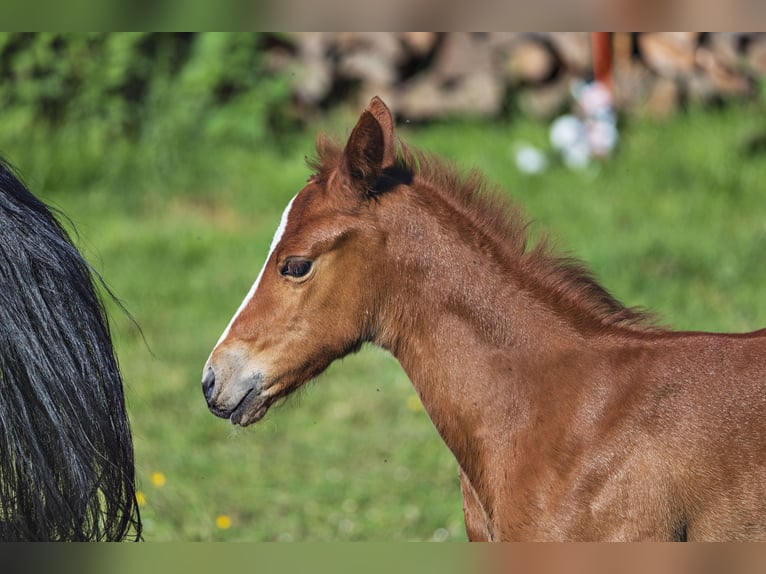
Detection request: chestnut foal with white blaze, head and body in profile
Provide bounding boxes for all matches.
[203,98,766,540]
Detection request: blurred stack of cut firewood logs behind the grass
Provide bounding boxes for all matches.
[284,32,766,119]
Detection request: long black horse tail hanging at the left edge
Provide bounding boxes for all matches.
[0,159,141,541]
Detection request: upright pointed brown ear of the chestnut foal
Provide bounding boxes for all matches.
[343,96,394,197]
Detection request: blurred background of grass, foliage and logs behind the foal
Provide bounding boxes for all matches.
[0,32,766,541]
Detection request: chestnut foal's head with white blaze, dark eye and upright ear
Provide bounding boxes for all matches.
[202,98,397,426]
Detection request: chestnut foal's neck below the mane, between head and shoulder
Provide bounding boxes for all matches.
[376,186,583,486]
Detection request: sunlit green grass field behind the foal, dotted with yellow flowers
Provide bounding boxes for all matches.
[2,101,766,541]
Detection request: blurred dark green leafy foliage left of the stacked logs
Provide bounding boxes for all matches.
[0,32,297,190]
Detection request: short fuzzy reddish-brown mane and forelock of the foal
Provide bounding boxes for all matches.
[308,135,660,330]
